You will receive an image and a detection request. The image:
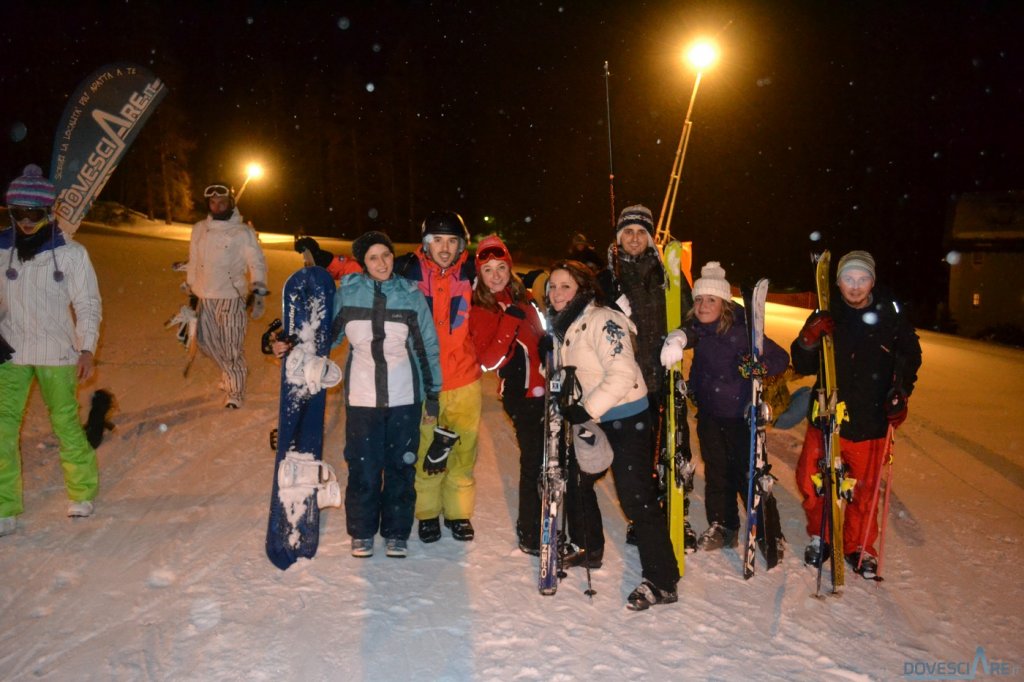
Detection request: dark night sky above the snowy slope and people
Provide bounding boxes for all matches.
[0,1,1024,325]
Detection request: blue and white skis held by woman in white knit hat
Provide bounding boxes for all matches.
[743,280,782,580]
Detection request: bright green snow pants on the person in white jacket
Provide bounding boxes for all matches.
[0,363,99,516]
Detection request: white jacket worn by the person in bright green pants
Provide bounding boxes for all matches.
[0,228,101,366]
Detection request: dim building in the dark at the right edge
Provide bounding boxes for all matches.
[946,190,1024,337]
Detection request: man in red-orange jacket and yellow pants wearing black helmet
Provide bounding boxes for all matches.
[394,211,481,543]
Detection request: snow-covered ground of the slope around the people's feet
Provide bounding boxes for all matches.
[0,220,1024,680]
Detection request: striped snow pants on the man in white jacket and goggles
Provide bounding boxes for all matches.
[197,298,248,400]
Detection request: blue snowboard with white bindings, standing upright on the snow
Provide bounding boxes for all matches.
[266,267,335,570]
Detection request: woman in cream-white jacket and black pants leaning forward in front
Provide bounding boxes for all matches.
[548,260,679,610]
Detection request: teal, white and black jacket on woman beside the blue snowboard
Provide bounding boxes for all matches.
[334,274,441,408]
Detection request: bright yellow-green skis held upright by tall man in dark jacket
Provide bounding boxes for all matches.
[662,240,693,576]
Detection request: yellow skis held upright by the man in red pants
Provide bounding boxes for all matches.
[814,251,846,594]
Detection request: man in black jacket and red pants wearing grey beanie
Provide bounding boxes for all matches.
[790,251,921,578]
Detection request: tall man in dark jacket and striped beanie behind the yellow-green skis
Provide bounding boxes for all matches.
[597,204,696,551]
